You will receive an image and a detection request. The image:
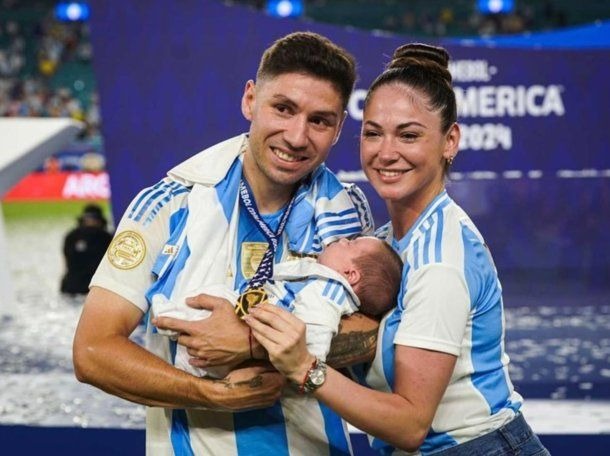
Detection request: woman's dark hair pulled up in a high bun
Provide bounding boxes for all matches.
[364,43,457,133]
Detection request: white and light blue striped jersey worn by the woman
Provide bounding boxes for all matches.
[366,191,522,455]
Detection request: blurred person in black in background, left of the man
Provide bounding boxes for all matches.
[61,204,112,295]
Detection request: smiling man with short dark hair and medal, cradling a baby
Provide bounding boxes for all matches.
[74,33,372,455]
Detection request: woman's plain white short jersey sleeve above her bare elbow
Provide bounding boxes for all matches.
[394,263,470,356]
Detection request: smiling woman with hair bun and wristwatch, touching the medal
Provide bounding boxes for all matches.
[246,44,549,455]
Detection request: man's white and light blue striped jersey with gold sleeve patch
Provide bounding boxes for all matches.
[92,136,372,456]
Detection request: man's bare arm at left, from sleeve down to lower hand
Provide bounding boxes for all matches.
[73,287,283,410]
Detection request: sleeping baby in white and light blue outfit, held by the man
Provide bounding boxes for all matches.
[152,237,402,378]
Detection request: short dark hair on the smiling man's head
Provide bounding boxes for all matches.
[256,32,356,109]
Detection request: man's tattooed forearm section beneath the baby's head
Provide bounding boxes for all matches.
[326,312,379,368]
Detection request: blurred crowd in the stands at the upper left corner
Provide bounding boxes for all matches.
[0,0,101,138]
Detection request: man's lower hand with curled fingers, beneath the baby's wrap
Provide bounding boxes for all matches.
[206,363,286,411]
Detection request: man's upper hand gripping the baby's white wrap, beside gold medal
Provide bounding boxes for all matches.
[153,294,250,368]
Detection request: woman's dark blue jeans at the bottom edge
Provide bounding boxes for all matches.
[434,413,551,456]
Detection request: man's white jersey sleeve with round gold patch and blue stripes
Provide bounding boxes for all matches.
[90,179,188,312]
